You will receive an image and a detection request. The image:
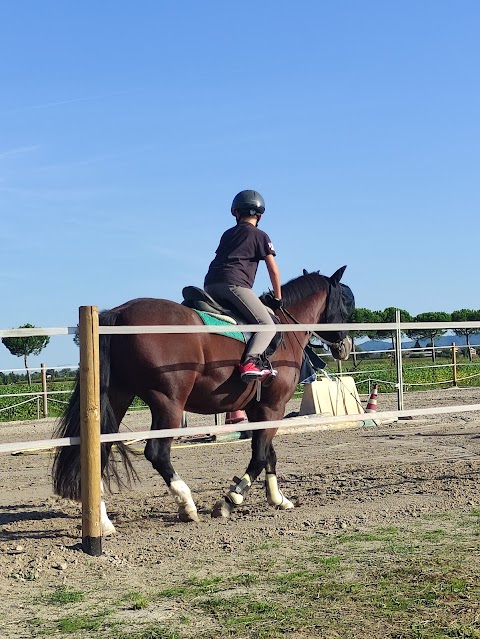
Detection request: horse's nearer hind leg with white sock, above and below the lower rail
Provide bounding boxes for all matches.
[145,396,198,522]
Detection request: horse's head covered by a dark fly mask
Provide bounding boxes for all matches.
[303,266,355,361]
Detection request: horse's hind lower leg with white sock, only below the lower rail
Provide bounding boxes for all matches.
[145,438,199,522]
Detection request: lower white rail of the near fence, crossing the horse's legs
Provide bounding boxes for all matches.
[0,404,480,453]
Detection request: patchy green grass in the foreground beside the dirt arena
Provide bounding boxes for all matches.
[25,508,480,639]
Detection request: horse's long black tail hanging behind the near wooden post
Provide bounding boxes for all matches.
[52,311,136,500]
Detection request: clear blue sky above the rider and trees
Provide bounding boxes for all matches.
[0,0,480,369]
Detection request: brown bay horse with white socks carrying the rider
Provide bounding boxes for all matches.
[52,266,354,536]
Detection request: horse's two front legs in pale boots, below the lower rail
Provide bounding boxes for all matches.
[212,429,293,518]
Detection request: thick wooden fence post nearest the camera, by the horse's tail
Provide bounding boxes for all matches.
[79,306,102,556]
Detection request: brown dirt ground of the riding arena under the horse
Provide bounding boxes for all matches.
[0,389,480,638]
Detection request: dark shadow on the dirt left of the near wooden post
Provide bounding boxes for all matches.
[0,504,74,541]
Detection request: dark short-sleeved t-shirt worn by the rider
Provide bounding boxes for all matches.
[204,222,275,288]
